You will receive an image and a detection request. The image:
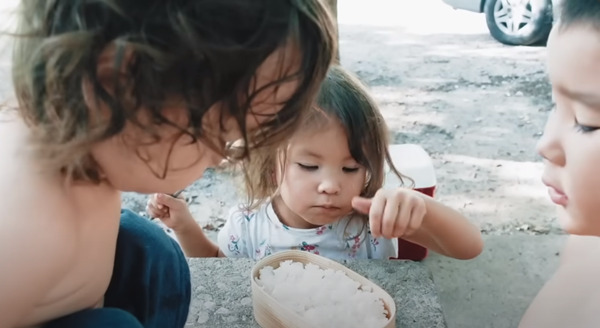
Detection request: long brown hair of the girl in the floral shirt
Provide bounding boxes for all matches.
[241,65,412,209]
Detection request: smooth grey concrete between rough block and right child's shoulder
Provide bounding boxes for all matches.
[424,234,566,328]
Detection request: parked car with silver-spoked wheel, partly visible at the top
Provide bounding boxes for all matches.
[444,0,559,45]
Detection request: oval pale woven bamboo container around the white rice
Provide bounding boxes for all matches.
[251,250,396,328]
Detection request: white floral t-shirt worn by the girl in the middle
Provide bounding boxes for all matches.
[218,202,398,260]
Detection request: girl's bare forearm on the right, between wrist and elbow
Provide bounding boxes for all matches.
[402,195,483,259]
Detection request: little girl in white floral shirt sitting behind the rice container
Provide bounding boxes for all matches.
[148,67,483,260]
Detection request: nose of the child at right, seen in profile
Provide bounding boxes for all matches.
[536,112,566,166]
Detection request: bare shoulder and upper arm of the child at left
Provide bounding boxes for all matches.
[0,114,76,326]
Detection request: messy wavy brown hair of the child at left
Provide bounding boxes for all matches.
[13,0,337,182]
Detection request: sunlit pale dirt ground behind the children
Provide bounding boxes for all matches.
[124,0,560,235]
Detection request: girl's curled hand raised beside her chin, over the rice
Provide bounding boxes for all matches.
[352,188,427,239]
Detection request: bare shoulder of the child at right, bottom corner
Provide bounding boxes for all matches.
[520,236,600,328]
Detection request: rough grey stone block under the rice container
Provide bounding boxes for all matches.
[186,258,446,328]
